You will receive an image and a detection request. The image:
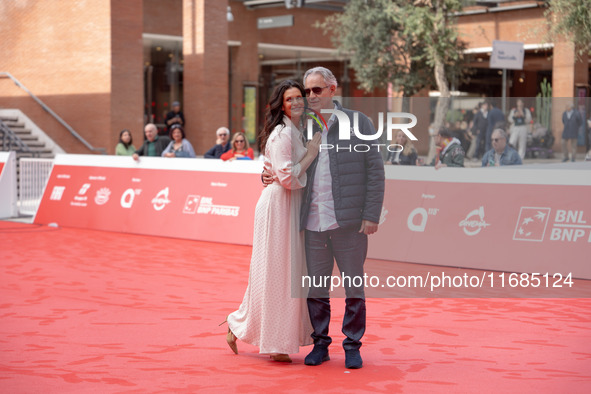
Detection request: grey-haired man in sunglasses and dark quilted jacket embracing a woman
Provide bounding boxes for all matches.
[301,67,384,369]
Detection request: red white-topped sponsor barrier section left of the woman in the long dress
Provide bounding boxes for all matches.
[35,155,263,245]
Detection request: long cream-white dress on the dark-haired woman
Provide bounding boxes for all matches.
[228,116,313,354]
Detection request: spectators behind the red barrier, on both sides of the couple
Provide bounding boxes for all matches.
[115,99,591,165]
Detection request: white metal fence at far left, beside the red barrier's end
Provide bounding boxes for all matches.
[19,157,53,215]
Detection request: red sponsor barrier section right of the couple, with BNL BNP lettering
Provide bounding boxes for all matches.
[368,163,591,279]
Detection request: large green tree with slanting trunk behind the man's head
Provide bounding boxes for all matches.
[320,0,465,125]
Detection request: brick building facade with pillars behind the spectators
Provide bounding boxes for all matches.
[0,0,589,154]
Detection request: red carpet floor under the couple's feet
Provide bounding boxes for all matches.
[0,221,591,393]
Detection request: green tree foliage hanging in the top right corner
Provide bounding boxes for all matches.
[545,0,591,54]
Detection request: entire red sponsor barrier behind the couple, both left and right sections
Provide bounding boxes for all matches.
[35,155,591,279]
